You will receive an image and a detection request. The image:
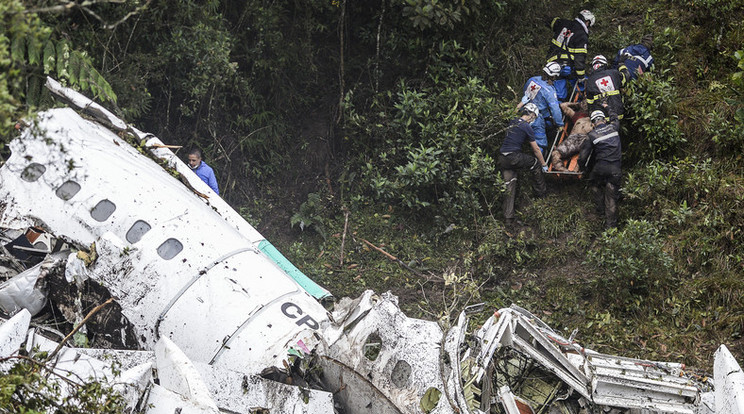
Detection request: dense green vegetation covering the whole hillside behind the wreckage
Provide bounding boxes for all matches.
[0,0,744,404]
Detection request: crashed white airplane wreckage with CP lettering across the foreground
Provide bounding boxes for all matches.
[0,79,744,414]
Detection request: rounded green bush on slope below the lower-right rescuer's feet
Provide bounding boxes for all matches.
[586,220,673,310]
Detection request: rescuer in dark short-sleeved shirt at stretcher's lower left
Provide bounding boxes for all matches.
[497,103,548,227]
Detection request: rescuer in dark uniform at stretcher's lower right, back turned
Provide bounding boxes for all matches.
[579,104,622,229]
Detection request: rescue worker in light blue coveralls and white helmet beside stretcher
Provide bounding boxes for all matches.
[517,62,563,154]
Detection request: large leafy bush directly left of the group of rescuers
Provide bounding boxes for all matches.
[346,43,504,220]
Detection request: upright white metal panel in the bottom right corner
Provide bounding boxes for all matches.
[713,345,744,414]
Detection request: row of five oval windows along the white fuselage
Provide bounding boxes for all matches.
[21,162,183,260]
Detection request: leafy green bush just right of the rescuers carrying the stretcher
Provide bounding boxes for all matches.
[626,73,687,160]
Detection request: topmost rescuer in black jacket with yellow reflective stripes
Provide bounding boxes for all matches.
[548,10,596,101]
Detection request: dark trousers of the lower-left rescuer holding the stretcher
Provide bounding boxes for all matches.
[498,152,547,223]
